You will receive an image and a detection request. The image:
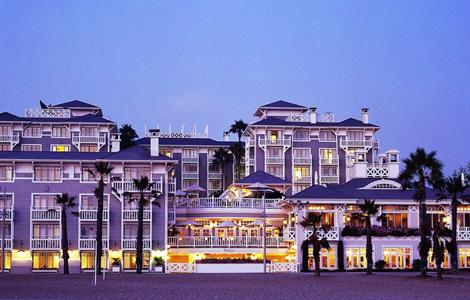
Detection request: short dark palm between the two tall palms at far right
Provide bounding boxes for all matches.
[430,223,454,281]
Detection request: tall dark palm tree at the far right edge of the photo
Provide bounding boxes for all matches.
[438,172,470,273]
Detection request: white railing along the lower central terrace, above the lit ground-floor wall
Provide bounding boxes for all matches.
[168,236,289,248]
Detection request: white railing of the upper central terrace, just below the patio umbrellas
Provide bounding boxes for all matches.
[175,198,280,209]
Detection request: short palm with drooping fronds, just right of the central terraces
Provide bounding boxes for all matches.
[299,213,330,277]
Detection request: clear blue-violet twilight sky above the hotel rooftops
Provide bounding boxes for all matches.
[0,0,470,172]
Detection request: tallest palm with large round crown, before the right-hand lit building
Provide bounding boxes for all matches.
[398,148,443,277]
